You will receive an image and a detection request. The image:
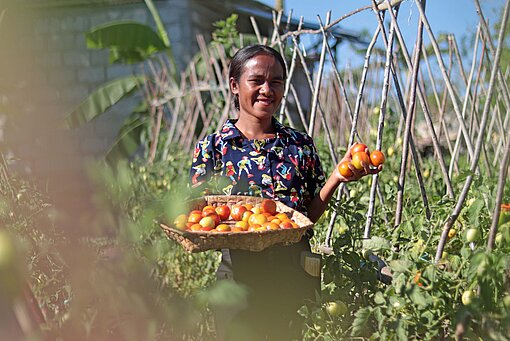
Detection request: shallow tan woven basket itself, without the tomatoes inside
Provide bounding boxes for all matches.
[160,195,313,252]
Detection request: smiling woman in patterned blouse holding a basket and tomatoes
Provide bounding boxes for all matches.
[190,45,381,340]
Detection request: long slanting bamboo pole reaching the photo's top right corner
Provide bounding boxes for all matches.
[435,0,510,263]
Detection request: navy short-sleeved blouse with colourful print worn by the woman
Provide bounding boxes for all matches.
[190,118,325,214]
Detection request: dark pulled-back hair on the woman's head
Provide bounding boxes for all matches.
[228,45,287,110]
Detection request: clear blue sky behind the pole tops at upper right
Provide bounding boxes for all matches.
[259,0,505,64]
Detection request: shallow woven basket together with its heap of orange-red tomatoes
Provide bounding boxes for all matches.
[160,195,313,252]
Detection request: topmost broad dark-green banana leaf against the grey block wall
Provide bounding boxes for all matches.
[85,20,168,64]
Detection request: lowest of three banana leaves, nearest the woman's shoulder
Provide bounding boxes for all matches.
[105,114,150,163]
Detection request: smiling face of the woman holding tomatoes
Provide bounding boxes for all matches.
[230,54,285,119]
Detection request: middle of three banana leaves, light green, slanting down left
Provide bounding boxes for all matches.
[64,75,143,128]
